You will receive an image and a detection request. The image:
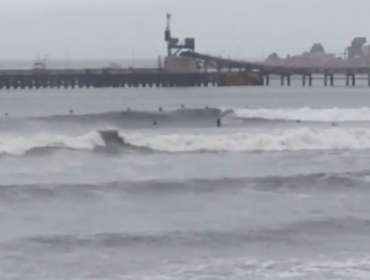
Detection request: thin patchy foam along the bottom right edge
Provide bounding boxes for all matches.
[123,256,370,280]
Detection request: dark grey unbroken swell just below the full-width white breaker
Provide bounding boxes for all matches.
[0,170,370,197]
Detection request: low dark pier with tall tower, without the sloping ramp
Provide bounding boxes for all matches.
[0,14,263,89]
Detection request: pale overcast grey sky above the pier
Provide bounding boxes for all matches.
[0,0,370,60]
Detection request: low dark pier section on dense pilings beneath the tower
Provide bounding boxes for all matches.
[0,69,263,89]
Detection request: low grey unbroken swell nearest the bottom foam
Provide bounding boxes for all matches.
[12,216,370,254]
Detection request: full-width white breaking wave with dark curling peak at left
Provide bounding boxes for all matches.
[0,127,370,155]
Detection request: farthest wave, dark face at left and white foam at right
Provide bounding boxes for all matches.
[5,107,370,130]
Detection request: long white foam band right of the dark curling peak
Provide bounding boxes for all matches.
[124,127,370,152]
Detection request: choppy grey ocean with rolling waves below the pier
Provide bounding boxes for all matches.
[0,84,370,280]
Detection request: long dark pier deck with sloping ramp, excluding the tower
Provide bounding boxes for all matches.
[0,51,370,89]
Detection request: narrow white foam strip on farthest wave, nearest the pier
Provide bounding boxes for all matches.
[234,107,370,122]
